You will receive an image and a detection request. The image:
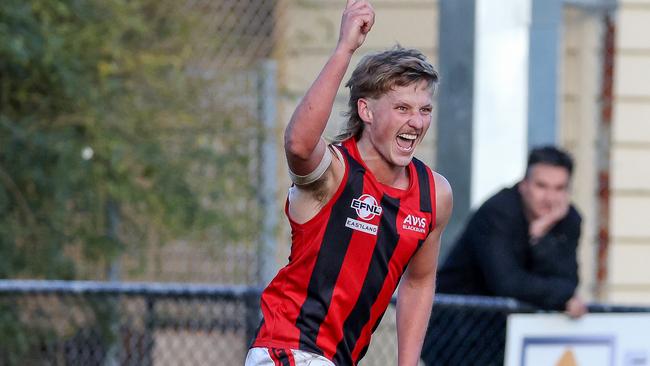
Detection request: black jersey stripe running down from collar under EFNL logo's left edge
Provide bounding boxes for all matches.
[296,149,365,355]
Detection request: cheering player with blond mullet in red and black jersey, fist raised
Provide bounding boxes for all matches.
[246,0,451,366]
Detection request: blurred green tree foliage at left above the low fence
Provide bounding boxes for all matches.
[0,0,255,279]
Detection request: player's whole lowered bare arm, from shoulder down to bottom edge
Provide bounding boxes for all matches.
[397,173,453,366]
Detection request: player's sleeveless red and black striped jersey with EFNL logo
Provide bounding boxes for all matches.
[253,139,436,365]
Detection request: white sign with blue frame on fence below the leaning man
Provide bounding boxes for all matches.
[505,313,650,366]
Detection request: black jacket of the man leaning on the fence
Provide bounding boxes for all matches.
[436,185,581,310]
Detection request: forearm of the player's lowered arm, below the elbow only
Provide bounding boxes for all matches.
[397,280,435,366]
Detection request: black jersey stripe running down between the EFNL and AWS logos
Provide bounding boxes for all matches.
[334,195,400,365]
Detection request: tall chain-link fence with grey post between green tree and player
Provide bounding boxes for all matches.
[112,0,286,284]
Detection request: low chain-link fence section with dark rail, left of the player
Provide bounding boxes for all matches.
[0,281,259,366]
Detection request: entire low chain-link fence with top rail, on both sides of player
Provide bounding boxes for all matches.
[0,281,650,365]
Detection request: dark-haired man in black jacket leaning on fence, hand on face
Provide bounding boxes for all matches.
[423,146,587,365]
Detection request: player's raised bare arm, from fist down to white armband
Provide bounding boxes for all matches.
[284,0,375,176]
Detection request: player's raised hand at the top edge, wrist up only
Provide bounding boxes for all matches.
[337,0,375,53]
